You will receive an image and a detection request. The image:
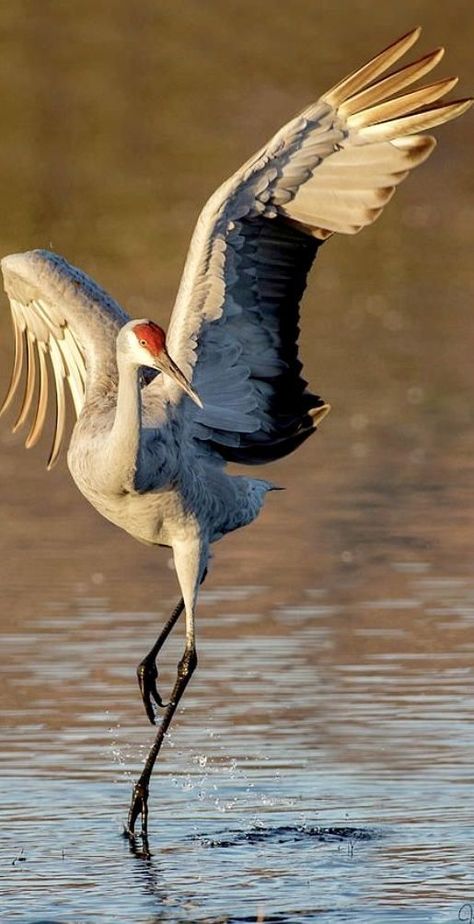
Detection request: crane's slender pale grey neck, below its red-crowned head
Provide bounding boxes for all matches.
[107,354,142,492]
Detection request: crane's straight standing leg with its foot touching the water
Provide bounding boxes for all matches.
[127,539,207,847]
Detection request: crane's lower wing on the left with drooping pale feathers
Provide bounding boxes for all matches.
[0,250,130,468]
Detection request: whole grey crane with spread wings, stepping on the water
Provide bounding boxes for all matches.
[1,29,472,842]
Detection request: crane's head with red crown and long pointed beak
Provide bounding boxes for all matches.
[117,320,202,407]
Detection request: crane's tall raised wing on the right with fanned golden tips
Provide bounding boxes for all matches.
[145,29,471,463]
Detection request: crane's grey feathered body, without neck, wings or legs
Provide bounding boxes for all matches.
[68,404,272,547]
